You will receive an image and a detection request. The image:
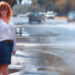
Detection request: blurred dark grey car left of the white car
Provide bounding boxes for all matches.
[28,12,41,23]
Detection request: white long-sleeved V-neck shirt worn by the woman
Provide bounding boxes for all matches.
[0,19,16,51]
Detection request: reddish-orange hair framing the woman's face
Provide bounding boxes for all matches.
[0,1,12,19]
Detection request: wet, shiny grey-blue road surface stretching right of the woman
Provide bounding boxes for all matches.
[9,19,75,75]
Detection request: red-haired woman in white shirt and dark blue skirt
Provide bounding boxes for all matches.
[0,1,16,75]
